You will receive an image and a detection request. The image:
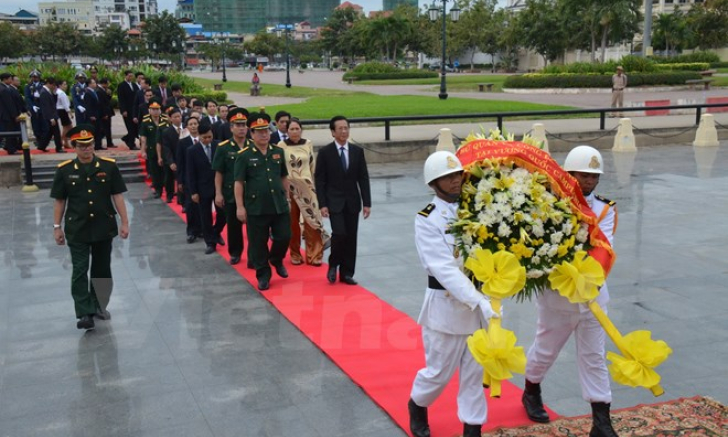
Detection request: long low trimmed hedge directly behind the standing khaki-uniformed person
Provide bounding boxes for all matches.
[503,71,701,88]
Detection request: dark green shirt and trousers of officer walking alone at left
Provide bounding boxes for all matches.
[51,152,126,318]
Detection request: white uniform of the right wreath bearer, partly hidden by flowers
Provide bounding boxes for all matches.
[526,193,617,403]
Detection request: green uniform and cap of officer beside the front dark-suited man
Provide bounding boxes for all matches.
[235,114,291,280]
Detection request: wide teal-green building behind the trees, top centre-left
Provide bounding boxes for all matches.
[194,0,339,35]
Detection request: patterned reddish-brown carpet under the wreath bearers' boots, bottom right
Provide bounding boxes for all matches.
[483,396,728,437]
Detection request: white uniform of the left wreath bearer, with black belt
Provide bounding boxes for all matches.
[411,197,487,425]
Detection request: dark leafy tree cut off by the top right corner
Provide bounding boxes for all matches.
[687,0,728,50]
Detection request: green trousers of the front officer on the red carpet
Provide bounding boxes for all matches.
[247,211,291,279]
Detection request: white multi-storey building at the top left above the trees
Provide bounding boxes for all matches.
[38,0,157,33]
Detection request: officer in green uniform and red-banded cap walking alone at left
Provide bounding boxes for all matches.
[51,125,129,330]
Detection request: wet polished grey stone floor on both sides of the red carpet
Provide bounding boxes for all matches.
[0,144,728,437]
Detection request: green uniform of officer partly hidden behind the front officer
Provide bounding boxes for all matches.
[212,138,251,258]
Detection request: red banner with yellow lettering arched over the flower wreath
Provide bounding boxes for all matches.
[456,139,616,276]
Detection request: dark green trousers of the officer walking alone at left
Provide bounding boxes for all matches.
[68,238,114,318]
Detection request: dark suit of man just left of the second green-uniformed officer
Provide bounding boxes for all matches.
[185,141,225,246]
